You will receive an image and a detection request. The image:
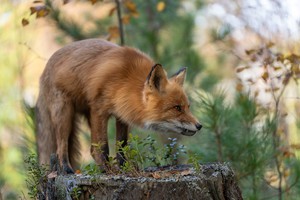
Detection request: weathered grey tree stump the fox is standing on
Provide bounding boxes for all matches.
[40,163,243,200]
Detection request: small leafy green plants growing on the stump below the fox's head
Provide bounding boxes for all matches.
[82,134,186,176]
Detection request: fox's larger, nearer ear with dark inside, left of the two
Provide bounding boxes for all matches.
[146,64,168,92]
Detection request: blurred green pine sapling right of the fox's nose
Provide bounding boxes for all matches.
[192,92,275,199]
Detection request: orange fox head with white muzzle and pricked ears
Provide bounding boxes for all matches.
[143,64,202,136]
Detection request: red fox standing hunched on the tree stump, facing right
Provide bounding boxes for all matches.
[36,39,202,173]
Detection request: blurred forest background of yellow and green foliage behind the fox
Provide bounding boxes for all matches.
[0,0,300,199]
